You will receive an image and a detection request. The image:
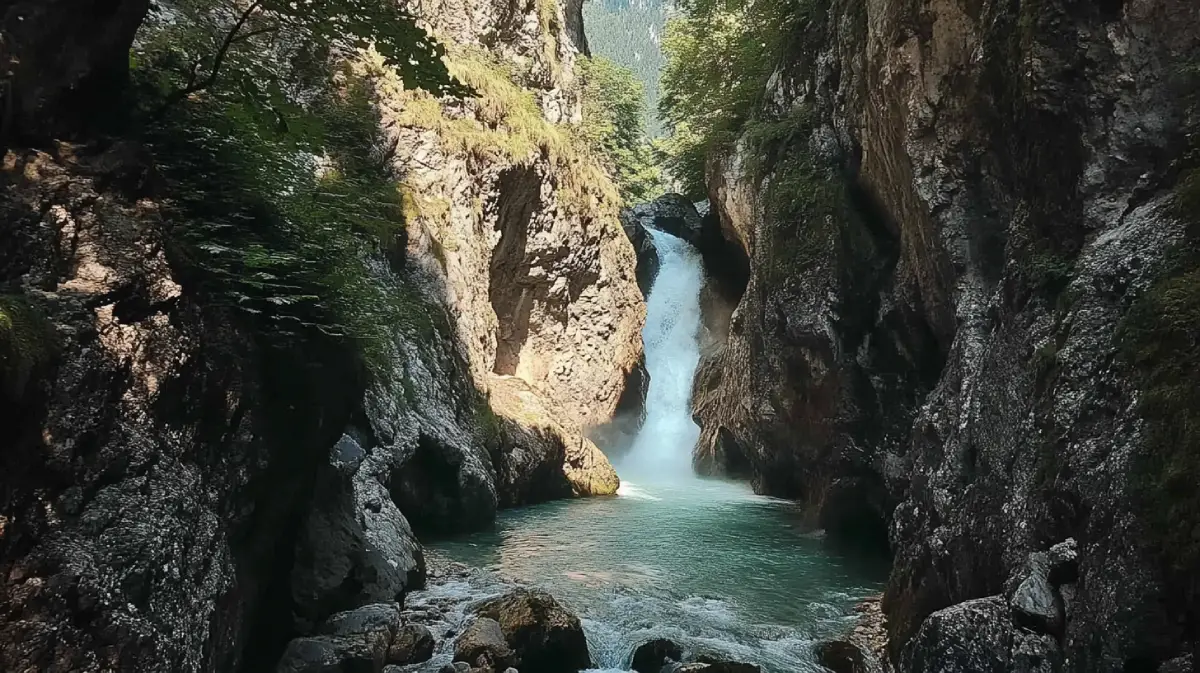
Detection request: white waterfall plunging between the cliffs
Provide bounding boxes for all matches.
[617,229,704,483]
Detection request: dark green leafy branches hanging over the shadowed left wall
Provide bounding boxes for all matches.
[124,0,466,365]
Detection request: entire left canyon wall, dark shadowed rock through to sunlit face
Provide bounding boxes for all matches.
[0,2,644,671]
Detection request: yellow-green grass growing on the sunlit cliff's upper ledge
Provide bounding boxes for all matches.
[367,47,620,216]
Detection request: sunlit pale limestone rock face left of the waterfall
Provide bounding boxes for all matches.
[380,0,646,436]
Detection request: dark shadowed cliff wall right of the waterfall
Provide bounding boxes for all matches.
[695,0,1200,672]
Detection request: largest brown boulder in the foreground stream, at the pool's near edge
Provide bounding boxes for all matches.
[476,588,592,673]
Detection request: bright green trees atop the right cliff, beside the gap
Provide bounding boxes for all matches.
[659,0,821,198]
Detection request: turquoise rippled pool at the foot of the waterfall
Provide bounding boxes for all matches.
[432,480,886,673]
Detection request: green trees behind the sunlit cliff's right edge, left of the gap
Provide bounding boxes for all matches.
[578,58,664,204]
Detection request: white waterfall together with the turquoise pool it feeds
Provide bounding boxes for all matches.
[427,232,886,673]
